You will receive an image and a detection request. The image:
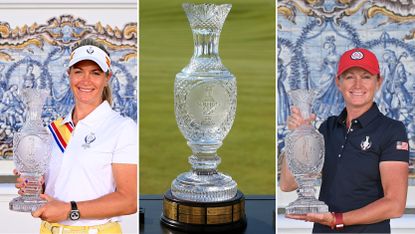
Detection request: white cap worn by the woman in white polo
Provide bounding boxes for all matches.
[68,45,111,72]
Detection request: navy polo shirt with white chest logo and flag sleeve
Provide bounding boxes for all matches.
[313,103,409,233]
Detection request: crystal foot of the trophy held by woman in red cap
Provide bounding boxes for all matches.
[285,197,329,214]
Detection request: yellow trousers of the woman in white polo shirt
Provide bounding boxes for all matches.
[40,221,122,234]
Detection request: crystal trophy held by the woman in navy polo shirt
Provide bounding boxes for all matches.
[285,89,328,214]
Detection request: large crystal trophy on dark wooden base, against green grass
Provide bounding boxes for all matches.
[161,3,246,232]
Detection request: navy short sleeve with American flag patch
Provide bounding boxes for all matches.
[380,121,409,162]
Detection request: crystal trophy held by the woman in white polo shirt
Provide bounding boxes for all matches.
[9,89,51,212]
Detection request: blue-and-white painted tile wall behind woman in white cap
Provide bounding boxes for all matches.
[0,15,137,159]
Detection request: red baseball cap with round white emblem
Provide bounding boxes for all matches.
[336,48,379,77]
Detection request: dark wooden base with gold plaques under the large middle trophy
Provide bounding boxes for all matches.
[161,190,246,233]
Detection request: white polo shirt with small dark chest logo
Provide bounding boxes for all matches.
[45,101,138,226]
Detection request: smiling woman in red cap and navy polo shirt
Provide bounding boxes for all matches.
[280,48,409,233]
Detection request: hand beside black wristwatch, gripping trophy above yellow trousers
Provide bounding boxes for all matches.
[32,194,71,223]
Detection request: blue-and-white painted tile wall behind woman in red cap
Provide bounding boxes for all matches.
[277,0,415,168]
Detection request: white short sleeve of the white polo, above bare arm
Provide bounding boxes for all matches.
[112,119,138,164]
